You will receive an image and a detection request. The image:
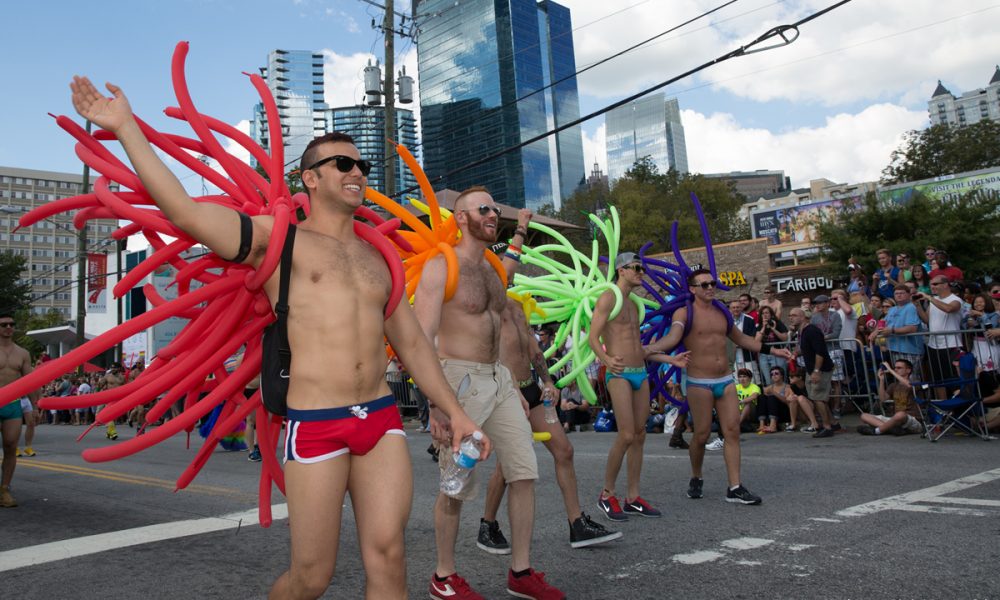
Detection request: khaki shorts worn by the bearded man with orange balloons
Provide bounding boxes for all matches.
[438,358,538,500]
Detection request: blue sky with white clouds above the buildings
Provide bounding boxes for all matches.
[0,0,1000,186]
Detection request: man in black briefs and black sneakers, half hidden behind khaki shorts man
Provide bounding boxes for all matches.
[476,298,622,554]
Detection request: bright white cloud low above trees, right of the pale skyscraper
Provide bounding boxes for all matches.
[681,104,927,187]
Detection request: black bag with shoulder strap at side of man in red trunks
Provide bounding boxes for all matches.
[260,225,295,417]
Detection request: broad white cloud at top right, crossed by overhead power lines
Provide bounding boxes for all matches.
[565,0,1000,108]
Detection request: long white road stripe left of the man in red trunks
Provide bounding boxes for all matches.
[0,504,288,573]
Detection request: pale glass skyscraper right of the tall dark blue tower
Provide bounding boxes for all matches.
[604,93,688,181]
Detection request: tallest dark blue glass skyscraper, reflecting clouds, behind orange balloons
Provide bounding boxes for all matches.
[418,0,585,208]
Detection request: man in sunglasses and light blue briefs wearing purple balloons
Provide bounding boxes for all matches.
[647,269,791,504]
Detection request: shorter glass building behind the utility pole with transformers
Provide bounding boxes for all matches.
[326,106,417,192]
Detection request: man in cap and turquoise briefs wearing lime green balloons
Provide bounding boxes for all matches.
[588,252,687,521]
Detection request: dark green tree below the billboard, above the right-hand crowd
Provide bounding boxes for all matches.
[817,192,1000,279]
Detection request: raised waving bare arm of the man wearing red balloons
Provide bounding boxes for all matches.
[70,76,258,258]
